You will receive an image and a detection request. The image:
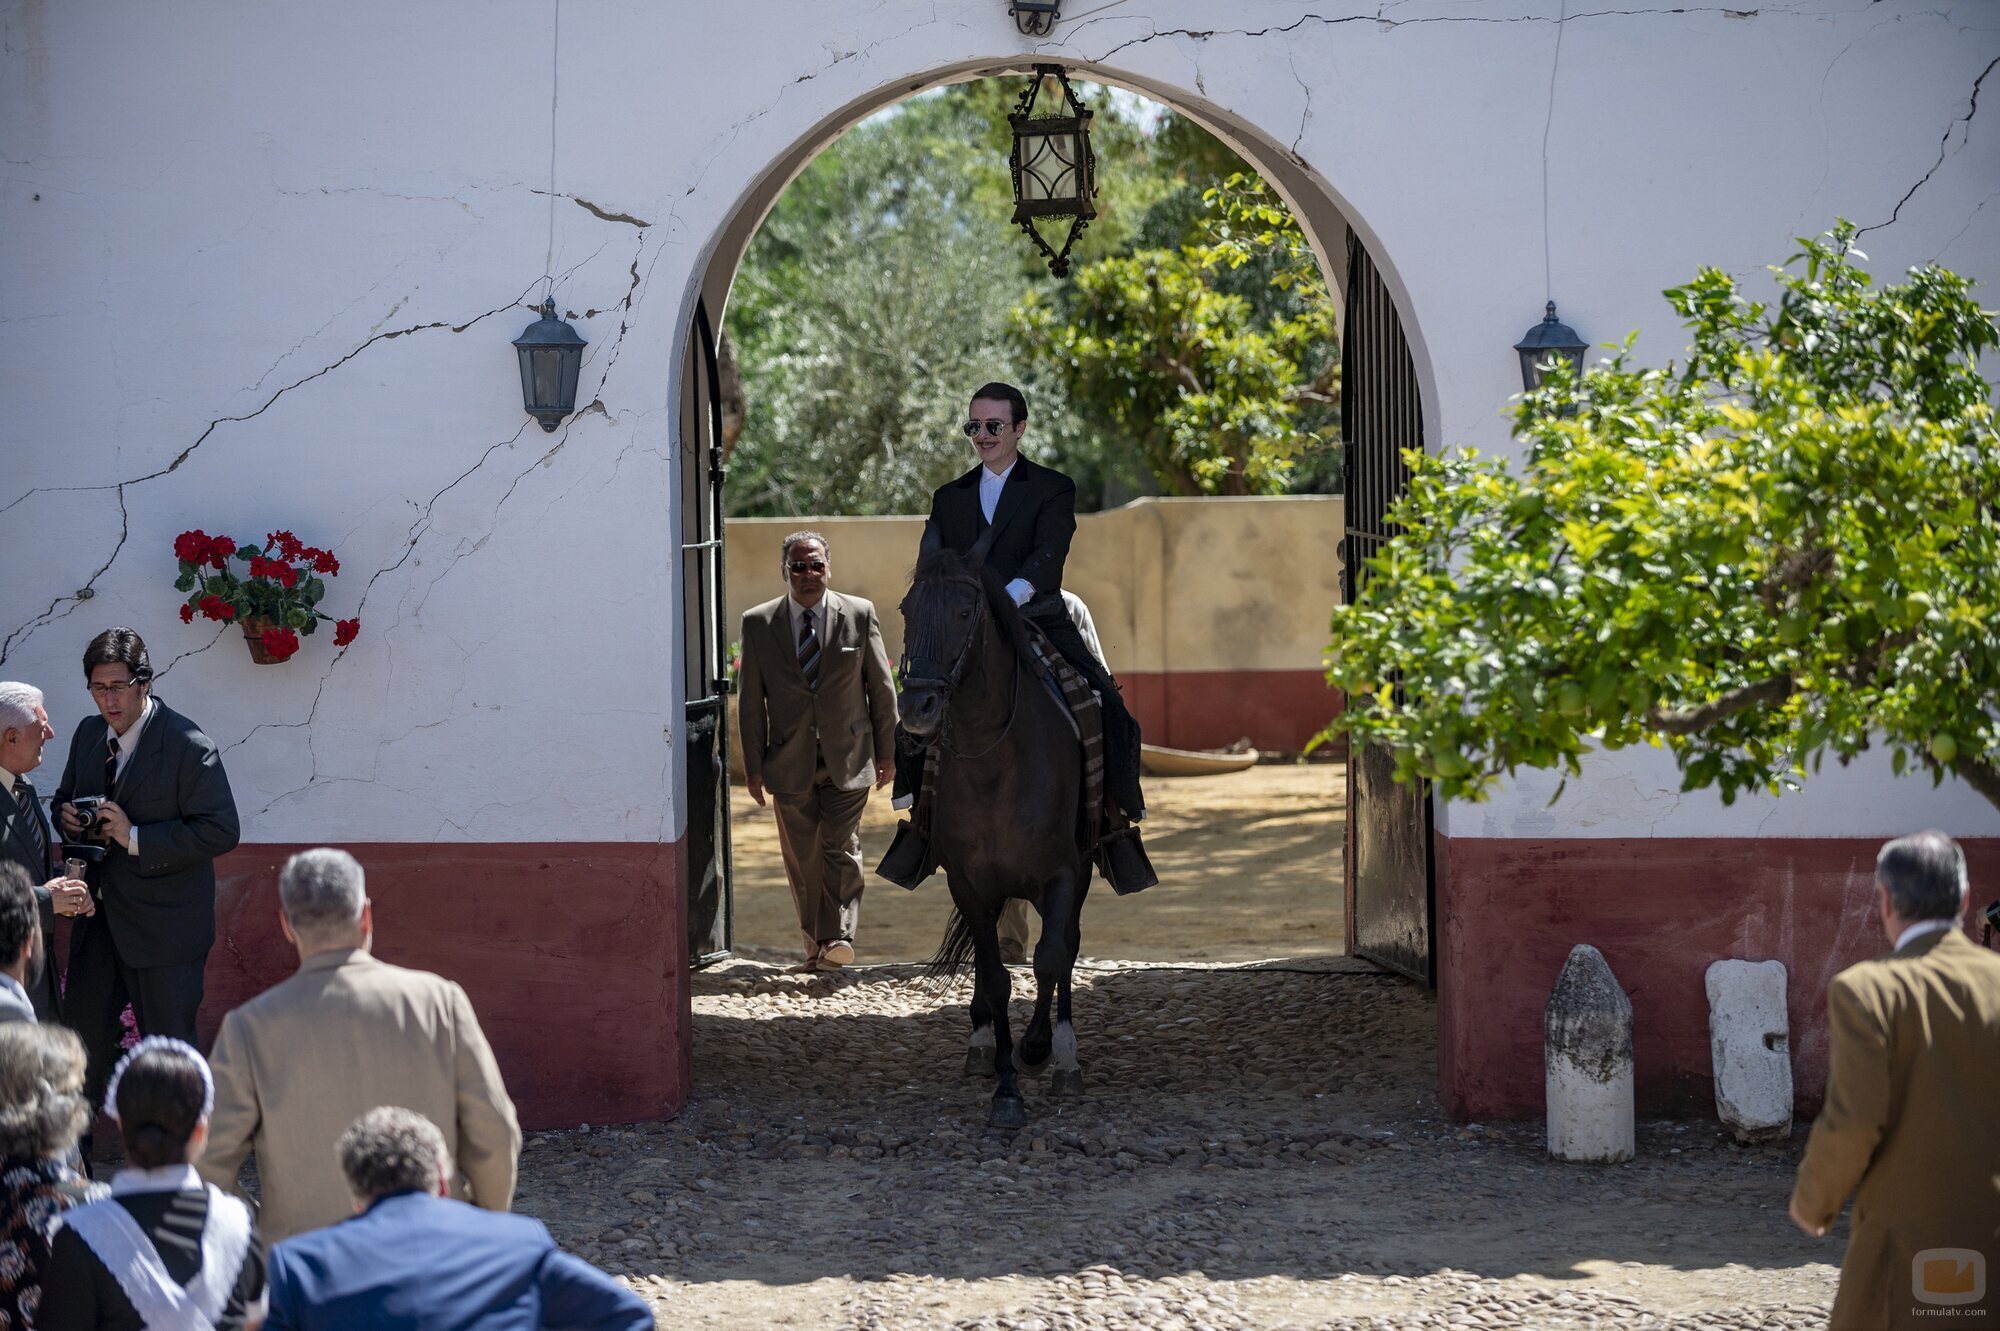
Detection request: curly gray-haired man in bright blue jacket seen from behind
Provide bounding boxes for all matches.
[264,1107,654,1331]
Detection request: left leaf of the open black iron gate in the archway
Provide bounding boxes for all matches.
[680,302,736,965]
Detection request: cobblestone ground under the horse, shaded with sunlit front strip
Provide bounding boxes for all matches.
[516,961,1846,1331]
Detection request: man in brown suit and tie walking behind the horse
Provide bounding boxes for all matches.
[738,532,896,971]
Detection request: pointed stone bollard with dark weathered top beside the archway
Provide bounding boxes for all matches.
[1542,943,1634,1165]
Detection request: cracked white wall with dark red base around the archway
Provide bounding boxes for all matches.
[0,0,2000,1123]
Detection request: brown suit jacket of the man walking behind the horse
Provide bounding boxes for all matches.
[736,592,896,795]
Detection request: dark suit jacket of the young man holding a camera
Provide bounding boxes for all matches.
[54,697,238,967]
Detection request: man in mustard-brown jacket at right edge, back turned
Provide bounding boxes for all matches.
[1792,831,2000,1331]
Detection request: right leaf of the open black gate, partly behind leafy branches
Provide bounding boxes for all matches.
[1340,234,1436,985]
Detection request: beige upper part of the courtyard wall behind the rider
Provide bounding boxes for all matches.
[724,496,1342,673]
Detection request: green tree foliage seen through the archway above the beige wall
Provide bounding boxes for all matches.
[726,80,1338,516]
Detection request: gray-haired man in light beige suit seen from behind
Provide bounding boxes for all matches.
[200,847,520,1243]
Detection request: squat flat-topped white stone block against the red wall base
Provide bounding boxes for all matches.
[1708,961,1792,1145]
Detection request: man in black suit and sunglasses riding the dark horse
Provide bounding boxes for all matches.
[876,384,1158,891]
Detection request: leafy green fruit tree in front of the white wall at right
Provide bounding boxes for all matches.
[1328,224,2000,803]
